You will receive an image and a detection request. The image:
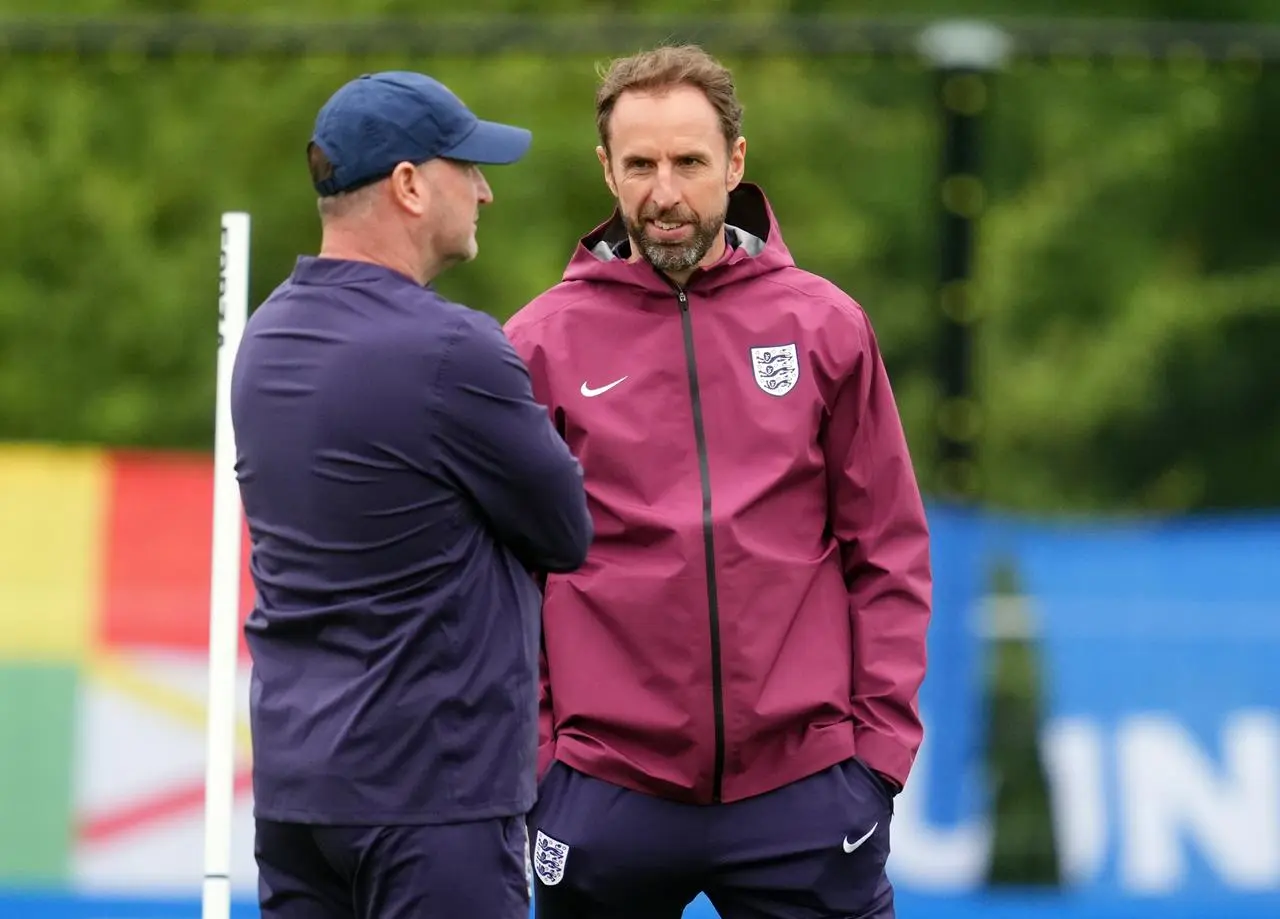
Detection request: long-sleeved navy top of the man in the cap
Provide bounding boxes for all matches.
[232,256,593,824]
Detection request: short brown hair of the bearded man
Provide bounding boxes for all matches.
[595,45,742,150]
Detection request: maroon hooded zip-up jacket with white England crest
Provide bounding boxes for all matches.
[506,184,932,803]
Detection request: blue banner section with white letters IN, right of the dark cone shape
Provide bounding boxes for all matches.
[1005,511,1280,915]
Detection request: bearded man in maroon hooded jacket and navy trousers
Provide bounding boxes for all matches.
[506,46,932,919]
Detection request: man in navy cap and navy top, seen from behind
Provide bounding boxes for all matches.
[232,72,593,919]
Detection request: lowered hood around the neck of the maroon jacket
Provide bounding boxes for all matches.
[563,182,795,294]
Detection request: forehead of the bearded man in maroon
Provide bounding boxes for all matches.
[609,86,724,156]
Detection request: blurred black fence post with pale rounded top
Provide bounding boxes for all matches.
[922,22,1009,503]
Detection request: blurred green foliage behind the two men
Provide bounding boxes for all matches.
[0,0,1280,511]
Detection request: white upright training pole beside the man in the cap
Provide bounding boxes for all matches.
[202,212,250,919]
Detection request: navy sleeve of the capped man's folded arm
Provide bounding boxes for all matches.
[439,314,594,571]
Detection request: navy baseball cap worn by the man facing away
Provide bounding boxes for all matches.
[311,70,532,195]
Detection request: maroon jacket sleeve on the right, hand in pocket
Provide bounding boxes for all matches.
[824,311,933,787]
